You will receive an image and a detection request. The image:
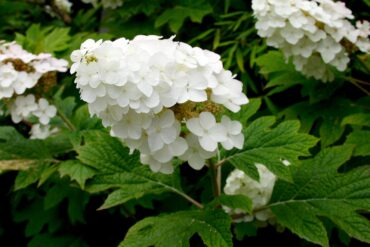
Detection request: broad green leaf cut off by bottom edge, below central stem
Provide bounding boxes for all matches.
[119,210,232,247]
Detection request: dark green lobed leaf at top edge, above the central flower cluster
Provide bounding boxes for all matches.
[155,0,212,33]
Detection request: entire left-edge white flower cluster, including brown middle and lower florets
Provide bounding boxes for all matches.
[0,39,68,139]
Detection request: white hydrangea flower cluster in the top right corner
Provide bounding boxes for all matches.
[252,0,370,81]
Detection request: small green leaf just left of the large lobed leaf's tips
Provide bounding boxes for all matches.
[58,160,96,189]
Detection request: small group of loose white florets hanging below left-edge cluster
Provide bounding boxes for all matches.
[9,94,57,139]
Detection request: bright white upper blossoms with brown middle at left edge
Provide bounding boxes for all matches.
[0,42,68,100]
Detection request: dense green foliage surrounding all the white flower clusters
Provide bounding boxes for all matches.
[0,0,370,247]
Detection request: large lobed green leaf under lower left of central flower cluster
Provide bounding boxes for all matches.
[76,131,184,209]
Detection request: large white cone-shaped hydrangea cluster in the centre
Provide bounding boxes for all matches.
[71,35,248,173]
